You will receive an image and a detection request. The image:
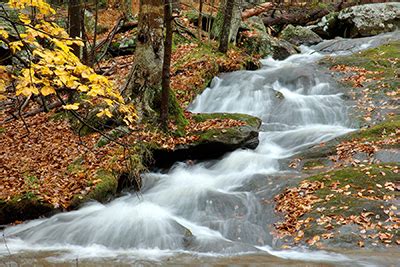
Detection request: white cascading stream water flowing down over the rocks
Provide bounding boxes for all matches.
[0,33,396,266]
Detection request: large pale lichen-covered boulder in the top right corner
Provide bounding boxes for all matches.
[338,3,400,38]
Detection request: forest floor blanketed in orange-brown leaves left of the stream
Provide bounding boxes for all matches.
[0,5,258,224]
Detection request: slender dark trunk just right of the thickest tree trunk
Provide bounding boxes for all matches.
[160,0,172,130]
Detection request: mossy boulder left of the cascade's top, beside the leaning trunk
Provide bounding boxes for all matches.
[239,16,298,60]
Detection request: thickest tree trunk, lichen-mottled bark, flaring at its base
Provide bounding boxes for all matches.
[122,0,164,118]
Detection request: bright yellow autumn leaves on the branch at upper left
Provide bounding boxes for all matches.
[0,0,136,124]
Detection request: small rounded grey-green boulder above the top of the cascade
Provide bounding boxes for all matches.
[280,25,322,46]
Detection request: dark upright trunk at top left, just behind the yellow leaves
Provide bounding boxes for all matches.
[68,0,82,58]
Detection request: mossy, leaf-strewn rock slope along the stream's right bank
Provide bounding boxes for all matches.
[275,42,400,248]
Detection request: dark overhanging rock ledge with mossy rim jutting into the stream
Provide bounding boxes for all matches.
[151,113,261,167]
